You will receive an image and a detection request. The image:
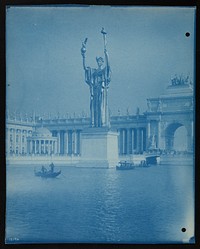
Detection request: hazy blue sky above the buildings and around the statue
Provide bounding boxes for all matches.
[6,5,195,115]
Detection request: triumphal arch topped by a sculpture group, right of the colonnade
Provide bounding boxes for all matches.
[146,76,194,152]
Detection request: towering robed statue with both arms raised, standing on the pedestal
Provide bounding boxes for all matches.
[81,28,111,127]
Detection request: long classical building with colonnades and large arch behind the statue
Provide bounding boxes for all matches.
[6,79,194,160]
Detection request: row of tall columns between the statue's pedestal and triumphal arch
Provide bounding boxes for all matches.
[118,127,146,155]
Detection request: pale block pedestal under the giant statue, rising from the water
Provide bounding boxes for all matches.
[77,128,118,168]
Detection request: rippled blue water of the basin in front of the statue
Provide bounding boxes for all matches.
[6,166,194,243]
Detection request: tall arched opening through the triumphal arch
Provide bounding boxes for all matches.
[165,123,187,151]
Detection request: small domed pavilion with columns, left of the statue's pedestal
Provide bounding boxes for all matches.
[27,127,57,155]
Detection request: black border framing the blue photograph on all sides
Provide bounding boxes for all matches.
[0,0,200,249]
